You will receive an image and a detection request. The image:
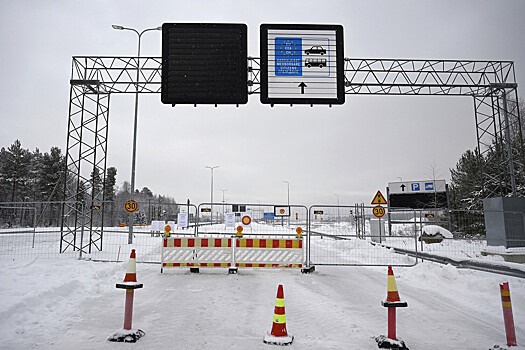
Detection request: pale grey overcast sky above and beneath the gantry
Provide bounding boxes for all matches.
[0,0,525,205]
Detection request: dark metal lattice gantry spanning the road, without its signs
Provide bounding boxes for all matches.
[60,57,525,253]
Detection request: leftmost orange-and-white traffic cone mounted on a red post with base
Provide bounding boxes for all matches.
[108,249,145,343]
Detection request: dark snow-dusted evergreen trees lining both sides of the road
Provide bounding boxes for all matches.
[0,100,525,210]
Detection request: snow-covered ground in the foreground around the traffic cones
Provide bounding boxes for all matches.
[0,228,525,350]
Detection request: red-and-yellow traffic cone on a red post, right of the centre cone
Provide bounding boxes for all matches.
[375,266,408,350]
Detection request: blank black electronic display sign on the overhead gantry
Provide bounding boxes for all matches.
[161,23,248,105]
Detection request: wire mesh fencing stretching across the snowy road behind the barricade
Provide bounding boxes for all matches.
[0,201,525,266]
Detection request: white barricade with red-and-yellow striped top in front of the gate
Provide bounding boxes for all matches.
[161,236,304,272]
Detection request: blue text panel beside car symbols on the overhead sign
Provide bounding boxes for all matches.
[275,38,303,77]
